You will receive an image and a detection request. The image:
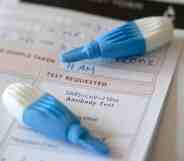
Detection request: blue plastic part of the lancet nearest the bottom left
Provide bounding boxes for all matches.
[23,94,109,155]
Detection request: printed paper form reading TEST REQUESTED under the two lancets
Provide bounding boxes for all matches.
[0,6,182,161]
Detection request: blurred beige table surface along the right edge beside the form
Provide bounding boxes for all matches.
[151,30,184,161]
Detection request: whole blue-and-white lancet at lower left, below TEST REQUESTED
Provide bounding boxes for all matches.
[2,83,110,156]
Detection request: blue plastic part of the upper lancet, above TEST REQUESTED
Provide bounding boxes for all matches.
[60,22,146,62]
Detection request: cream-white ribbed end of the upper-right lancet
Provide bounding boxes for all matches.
[135,16,174,52]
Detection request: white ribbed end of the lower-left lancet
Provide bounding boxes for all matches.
[2,83,43,122]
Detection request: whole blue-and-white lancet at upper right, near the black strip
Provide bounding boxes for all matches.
[60,17,174,62]
